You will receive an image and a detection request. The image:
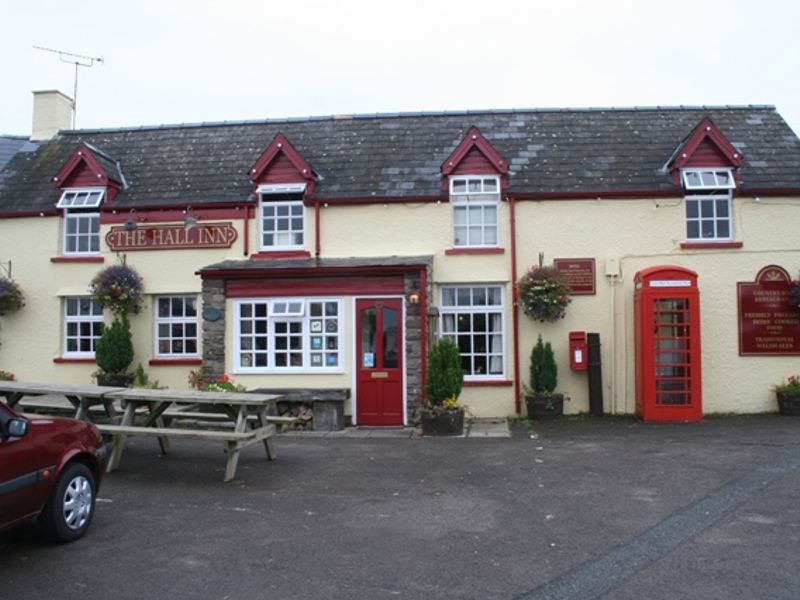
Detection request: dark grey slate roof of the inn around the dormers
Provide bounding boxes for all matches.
[0,106,800,213]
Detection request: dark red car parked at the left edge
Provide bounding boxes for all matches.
[0,402,108,542]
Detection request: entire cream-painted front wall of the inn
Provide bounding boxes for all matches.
[6,192,800,417]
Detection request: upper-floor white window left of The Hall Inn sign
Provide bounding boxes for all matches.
[56,188,106,255]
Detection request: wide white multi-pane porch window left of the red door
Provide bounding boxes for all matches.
[234,298,342,372]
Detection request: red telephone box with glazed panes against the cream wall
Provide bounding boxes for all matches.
[633,266,703,421]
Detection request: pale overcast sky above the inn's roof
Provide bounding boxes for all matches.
[0,0,800,135]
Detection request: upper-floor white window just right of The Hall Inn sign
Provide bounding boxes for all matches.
[257,183,306,250]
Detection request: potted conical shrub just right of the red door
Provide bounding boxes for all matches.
[421,338,464,435]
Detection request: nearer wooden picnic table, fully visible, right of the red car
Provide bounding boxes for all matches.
[97,388,281,481]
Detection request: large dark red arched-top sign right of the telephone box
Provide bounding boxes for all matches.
[736,265,800,356]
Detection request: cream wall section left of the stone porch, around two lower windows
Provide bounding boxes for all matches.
[0,217,244,388]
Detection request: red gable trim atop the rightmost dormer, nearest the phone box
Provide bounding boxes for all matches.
[667,117,744,185]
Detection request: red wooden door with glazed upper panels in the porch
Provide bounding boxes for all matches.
[356,298,403,425]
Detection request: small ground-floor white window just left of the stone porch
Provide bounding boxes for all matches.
[156,296,198,357]
